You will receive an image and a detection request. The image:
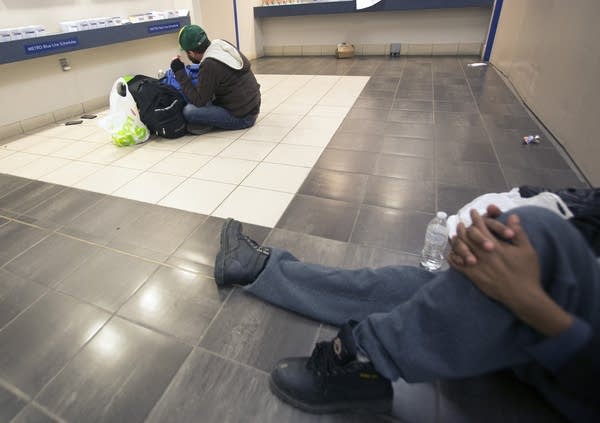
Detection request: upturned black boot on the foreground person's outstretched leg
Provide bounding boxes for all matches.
[215,219,271,286]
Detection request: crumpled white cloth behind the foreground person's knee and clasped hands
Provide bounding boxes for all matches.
[446,188,573,238]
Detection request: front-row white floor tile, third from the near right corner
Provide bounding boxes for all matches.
[113,172,185,204]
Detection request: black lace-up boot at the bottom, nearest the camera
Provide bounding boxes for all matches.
[270,324,394,414]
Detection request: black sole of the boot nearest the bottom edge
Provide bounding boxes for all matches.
[269,377,393,414]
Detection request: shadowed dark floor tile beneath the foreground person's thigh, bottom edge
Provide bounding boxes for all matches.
[439,372,564,423]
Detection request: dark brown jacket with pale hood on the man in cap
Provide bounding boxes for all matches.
[175,40,260,118]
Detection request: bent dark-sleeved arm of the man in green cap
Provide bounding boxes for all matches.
[171,57,218,107]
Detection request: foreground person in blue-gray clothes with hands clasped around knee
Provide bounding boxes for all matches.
[215,206,600,422]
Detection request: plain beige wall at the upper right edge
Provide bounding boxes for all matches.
[491,0,600,185]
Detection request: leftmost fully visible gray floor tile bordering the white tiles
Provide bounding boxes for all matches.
[19,188,104,229]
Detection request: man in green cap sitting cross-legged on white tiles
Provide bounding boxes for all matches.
[171,25,260,135]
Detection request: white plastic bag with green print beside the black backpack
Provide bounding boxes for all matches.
[98,78,150,147]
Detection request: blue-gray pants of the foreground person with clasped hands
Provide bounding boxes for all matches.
[245,207,600,420]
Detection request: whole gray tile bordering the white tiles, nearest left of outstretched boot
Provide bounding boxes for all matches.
[108,207,207,261]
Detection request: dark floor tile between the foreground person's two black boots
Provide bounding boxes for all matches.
[200,288,319,372]
